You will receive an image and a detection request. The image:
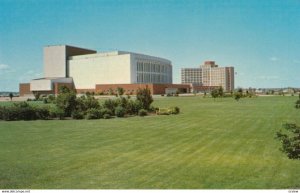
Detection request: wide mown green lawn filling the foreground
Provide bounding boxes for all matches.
[0,97,300,189]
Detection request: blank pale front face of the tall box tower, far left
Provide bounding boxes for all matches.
[44,45,66,77]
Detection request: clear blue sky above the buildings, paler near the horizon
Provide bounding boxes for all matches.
[0,0,300,91]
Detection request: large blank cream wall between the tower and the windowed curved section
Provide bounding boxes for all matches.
[68,54,132,89]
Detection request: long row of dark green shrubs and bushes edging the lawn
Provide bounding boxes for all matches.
[0,88,179,121]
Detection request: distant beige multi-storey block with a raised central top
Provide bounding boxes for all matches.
[181,61,234,91]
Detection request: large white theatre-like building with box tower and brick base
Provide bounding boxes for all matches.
[19,45,177,96]
